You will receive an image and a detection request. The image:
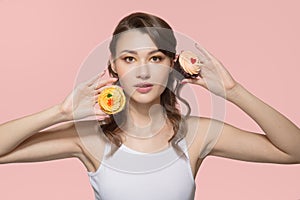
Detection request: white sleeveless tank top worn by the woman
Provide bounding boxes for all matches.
[87,139,196,200]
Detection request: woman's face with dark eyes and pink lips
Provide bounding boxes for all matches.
[111,30,173,103]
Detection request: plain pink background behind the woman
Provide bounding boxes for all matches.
[0,0,300,200]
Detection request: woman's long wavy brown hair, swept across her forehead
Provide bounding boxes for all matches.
[99,12,190,158]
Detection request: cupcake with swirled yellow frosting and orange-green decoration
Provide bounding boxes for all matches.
[98,85,126,115]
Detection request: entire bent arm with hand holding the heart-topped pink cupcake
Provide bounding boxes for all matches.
[183,44,300,163]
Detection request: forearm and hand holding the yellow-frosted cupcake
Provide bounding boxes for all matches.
[0,69,116,156]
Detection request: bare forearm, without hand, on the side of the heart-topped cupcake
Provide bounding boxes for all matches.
[220,84,300,163]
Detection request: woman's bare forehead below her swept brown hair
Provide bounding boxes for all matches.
[116,30,157,55]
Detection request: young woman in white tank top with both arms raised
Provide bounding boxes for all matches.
[0,13,300,200]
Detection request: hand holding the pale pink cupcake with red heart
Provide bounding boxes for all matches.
[181,44,238,98]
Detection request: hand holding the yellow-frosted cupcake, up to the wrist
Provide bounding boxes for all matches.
[60,70,118,120]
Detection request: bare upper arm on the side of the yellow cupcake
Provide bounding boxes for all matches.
[0,124,81,164]
